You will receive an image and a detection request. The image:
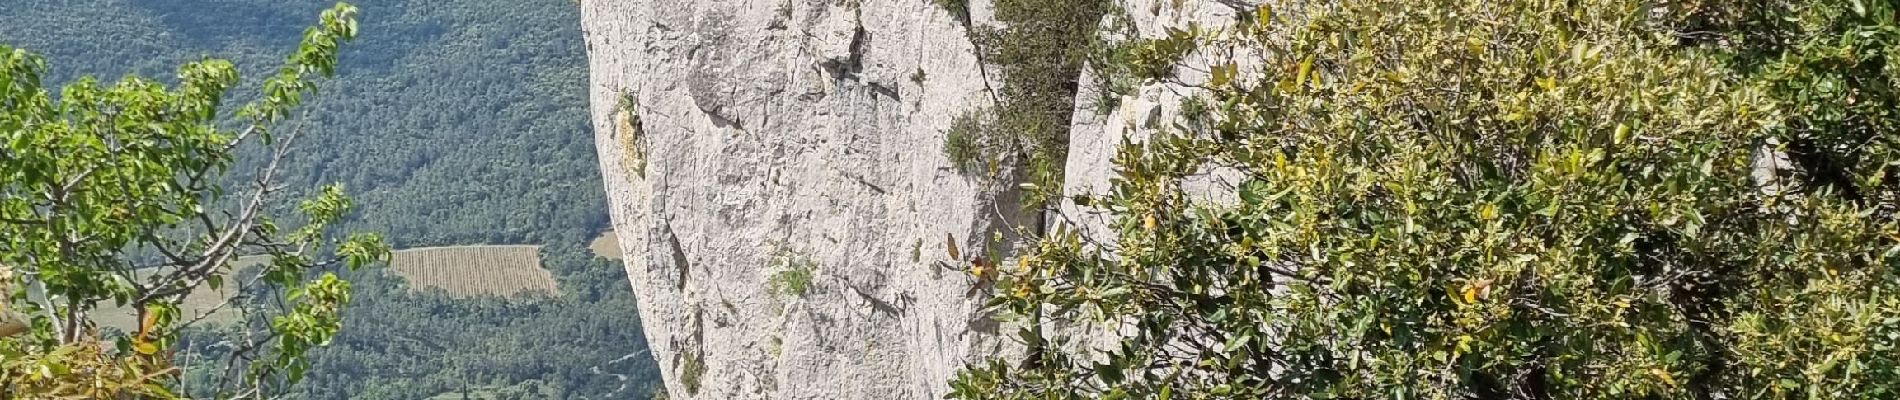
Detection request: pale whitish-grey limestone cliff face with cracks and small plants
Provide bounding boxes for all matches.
[581,0,1246,400]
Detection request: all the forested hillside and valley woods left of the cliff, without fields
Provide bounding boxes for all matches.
[0,0,657,398]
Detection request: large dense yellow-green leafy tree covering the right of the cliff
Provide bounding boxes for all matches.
[952,0,1900,398]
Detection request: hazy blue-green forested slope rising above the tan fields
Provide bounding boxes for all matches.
[0,0,608,246]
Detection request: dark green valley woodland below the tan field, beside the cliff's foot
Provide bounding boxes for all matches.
[256,252,659,400]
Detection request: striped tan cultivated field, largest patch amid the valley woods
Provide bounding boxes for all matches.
[390,246,557,296]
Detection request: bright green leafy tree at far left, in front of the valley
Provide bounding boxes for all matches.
[0,4,390,398]
